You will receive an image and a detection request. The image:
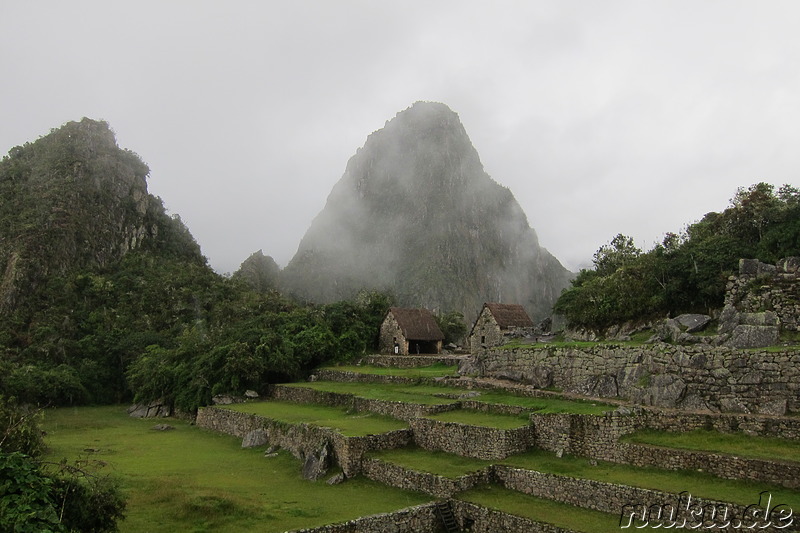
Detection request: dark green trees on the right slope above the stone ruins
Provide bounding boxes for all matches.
[554,183,800,332]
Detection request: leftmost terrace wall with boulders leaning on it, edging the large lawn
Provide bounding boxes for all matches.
[196,407,411,477]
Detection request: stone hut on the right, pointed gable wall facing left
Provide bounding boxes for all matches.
[469,303,534,353]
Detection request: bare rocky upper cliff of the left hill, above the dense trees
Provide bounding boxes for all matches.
[0,118,199,311]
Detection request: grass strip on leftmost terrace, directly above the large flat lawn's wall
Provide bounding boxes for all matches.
[219,401,408,437]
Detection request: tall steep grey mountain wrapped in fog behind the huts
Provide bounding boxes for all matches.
[282,102,571,319]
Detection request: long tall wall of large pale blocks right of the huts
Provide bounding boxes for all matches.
[466,344,800,415]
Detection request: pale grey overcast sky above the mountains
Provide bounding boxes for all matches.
[0,0,800,272]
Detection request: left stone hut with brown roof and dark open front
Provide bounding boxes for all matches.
[380,307,444,355]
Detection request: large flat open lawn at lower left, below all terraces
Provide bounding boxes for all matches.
[44,406,430,533]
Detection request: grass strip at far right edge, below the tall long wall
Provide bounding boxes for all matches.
[620,429,800,462]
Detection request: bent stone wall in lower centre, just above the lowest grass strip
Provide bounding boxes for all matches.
[361,458,494,498]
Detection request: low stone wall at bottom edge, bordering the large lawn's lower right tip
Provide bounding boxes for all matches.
[287,502,444,533]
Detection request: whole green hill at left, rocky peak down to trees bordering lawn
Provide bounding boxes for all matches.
[0,119,391,410]
